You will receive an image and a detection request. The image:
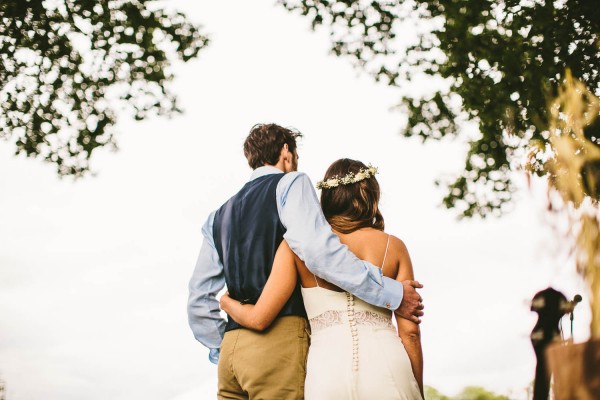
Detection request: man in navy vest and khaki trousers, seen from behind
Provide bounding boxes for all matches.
[188,124,423,399]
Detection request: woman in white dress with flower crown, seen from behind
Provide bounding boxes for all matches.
[221,159,423,400]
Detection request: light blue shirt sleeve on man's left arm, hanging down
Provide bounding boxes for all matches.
[187,213,226,364]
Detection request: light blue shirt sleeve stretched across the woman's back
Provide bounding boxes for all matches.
[277,172,403,310]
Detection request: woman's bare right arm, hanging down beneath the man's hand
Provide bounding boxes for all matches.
[390,236,424,398]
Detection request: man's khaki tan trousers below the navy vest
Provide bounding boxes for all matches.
[217,316,310,400]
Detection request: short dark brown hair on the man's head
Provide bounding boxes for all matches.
[244,124,302,169]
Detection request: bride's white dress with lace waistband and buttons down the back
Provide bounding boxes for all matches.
[302,287,422,400]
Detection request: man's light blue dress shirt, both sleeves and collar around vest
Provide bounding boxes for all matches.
[188,166,403,364]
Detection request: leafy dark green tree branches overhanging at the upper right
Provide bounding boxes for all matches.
[279,0,600,217]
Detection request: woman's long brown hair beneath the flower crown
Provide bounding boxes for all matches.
[321,158,385,233]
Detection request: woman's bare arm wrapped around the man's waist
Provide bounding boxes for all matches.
[221,240,297,331]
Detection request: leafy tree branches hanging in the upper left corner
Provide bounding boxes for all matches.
[0,0,208,176]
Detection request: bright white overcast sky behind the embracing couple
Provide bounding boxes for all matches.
[0,0,590,400]
